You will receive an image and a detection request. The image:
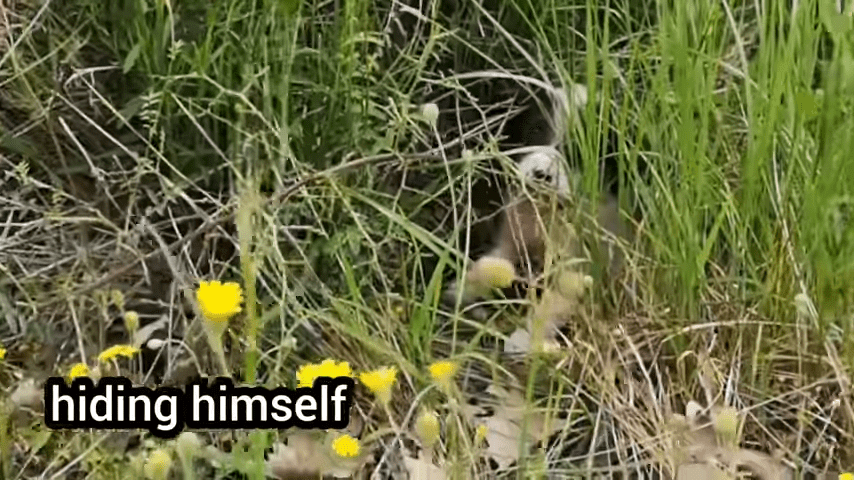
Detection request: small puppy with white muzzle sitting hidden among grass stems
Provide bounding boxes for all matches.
[444,82,628,337]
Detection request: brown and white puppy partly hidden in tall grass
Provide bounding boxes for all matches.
[443,82,629,315]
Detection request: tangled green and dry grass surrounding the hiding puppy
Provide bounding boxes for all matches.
[0,0,854,478]
